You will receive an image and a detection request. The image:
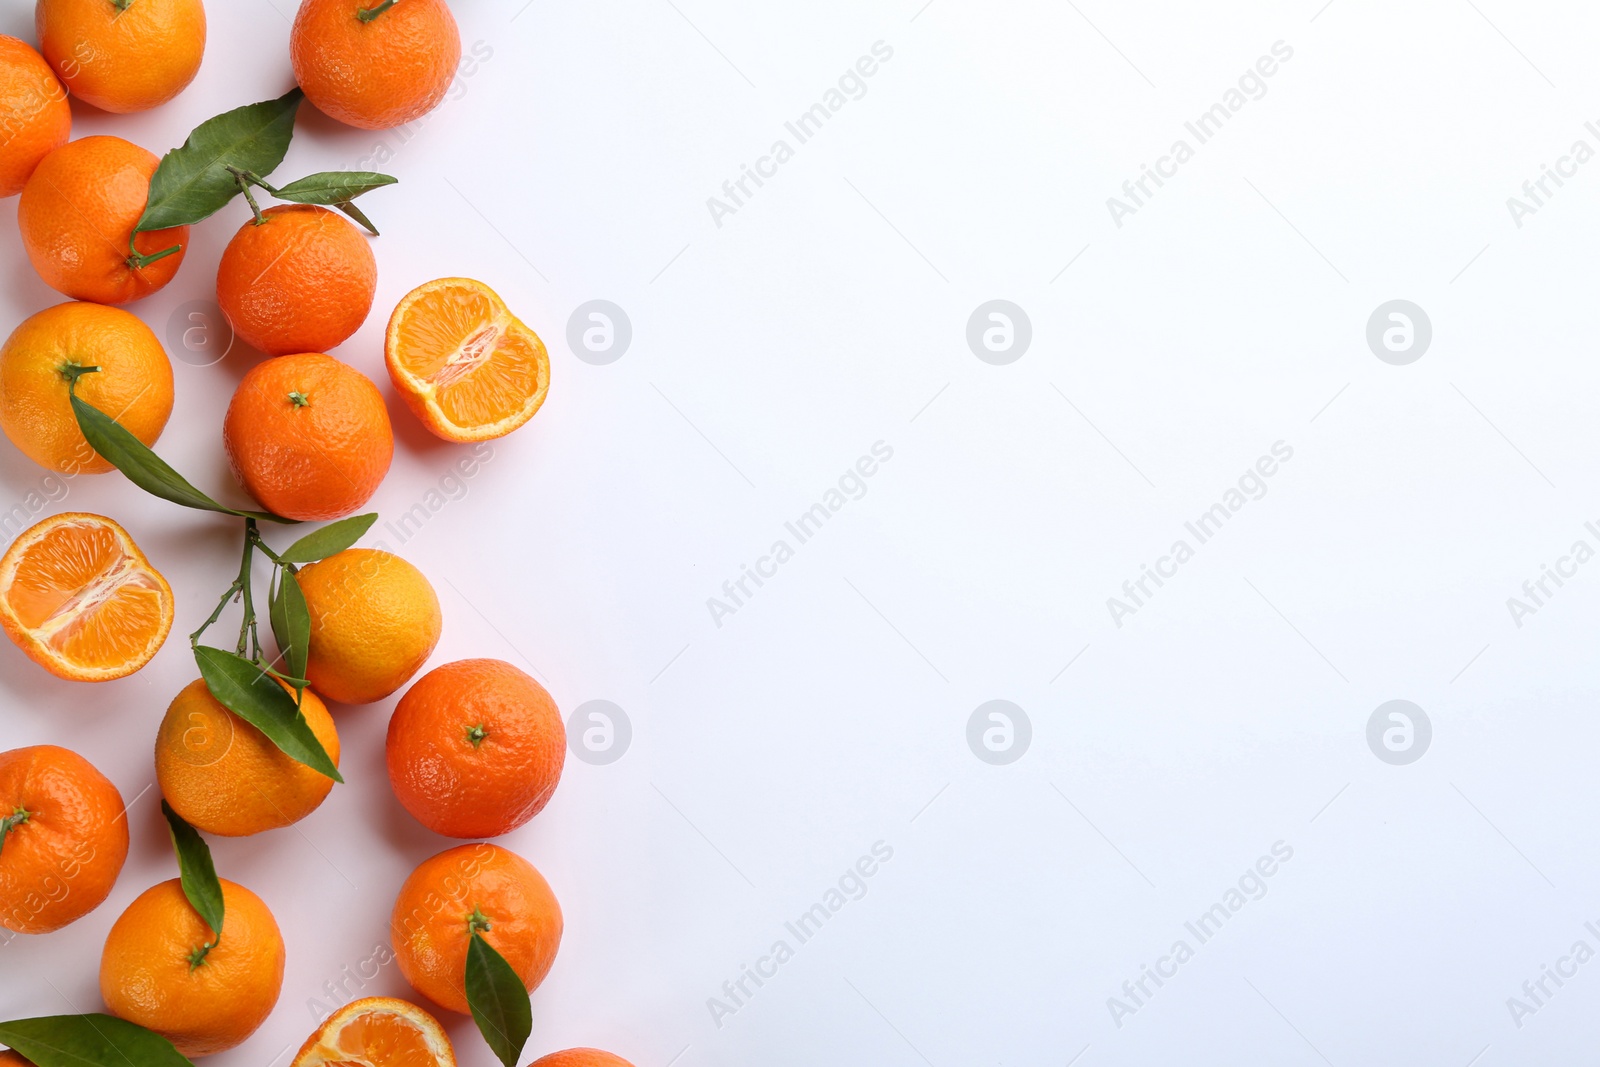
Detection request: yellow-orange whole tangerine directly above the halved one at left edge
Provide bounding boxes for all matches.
[0,302,173,474]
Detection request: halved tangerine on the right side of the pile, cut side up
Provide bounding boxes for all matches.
[384,278,550,442]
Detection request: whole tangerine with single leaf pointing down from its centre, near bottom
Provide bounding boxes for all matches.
[389,843,563,1014]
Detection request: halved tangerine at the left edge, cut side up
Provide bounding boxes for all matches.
[0,512,173,681]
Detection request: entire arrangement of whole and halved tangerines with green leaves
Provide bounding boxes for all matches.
[0,0,627,1067]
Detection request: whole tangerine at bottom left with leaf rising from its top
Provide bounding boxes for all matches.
[99,878,285,1059]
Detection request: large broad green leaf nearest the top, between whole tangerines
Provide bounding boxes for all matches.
[133,88,304,234]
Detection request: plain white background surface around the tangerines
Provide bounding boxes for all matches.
[0,0,1600,1067]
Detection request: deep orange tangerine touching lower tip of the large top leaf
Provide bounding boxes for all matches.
[16,135,189,304]
